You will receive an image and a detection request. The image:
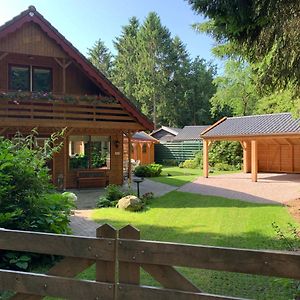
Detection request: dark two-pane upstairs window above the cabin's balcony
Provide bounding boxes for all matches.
[9,66,52,92]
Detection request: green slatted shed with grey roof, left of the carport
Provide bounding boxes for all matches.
[152,126,207,164]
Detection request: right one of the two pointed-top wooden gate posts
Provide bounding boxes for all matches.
[119,225,140,285]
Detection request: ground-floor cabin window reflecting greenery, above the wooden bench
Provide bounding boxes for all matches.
[69,135,110,169]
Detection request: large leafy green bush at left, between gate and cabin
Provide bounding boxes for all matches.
[0,131,74,269]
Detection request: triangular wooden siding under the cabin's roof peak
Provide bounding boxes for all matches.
[0,22,67,57]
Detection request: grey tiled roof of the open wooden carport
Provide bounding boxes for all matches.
[201,113,300,138]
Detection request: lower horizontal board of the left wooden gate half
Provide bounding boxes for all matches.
[0,270,113,300]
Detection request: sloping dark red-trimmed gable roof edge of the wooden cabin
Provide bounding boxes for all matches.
[0,6,153,130]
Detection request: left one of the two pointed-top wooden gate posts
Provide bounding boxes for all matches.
[96,224,117,299]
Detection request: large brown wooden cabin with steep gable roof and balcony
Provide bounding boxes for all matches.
[0,6,153,188]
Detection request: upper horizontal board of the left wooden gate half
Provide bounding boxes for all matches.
[0,229,115,261]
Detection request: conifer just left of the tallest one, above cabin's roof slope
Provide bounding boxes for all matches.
[112,17,140,104]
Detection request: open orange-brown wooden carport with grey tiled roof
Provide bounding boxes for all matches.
[201,113,300,182]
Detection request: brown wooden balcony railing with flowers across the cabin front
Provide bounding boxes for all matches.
[0,99,135,127]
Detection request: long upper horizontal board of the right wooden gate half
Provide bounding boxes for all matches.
[118,240,300,279]
